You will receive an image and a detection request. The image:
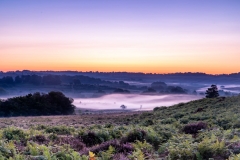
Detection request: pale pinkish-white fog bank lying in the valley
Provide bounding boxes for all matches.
[74,94,202,110]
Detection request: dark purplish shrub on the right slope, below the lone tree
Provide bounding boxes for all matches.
[183,122,207,134]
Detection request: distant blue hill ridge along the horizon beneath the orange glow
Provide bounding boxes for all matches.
[0,70,240,83]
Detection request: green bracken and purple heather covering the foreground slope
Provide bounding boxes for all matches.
[0,96,240,160]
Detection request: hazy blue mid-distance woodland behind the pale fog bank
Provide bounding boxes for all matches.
[0,74,192,97]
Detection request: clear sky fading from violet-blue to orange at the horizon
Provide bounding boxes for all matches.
[0,0,240,74]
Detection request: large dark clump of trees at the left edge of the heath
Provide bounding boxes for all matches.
[0,91,75,117]
